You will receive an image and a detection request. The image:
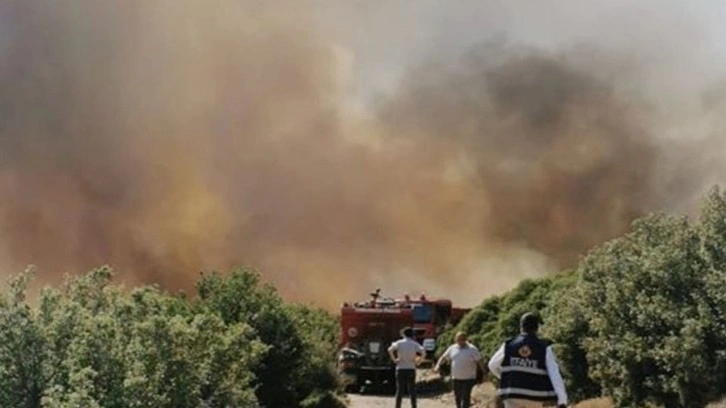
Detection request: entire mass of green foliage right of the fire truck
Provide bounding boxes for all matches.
[446,189,726,407]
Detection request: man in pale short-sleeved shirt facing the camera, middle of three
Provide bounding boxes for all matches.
[434,332,486,408]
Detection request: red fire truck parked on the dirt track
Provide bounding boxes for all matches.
[338,289,468,392]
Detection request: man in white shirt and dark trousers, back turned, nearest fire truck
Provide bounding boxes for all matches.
[388,327,426,408]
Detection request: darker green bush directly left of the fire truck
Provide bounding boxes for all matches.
[197,268,339,408]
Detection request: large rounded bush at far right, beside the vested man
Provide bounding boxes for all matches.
[579,215,726,407]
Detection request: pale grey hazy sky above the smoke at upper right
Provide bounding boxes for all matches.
[316,0,726,105]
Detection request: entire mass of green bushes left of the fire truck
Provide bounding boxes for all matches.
[0,268,340,408]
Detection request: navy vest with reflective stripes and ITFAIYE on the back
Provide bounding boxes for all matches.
[499,334,557,401]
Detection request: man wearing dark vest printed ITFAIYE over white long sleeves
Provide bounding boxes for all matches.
[489,313,567,408]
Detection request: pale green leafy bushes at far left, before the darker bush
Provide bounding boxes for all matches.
[0,268,282,408]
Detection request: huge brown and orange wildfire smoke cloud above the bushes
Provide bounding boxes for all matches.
[0,0,723,306]
